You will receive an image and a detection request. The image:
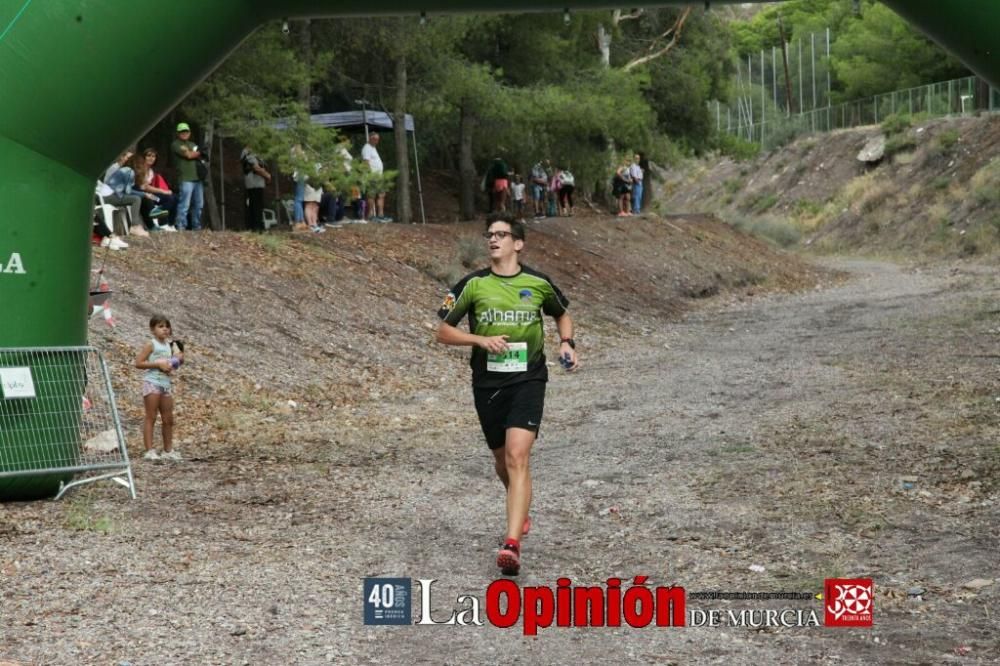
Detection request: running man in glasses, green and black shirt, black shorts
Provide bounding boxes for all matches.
[437,220,577,575]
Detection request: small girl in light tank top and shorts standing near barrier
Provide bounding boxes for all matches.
[135,314,184,460]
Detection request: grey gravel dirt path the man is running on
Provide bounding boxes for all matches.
[0,261,1000,666]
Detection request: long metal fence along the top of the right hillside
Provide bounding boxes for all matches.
[709,76,1000,147]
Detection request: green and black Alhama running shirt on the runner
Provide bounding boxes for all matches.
[438,266,569,388]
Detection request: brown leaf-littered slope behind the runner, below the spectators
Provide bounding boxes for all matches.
[82,217,824,443]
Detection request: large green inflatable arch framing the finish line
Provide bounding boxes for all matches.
[0,0,1000,500]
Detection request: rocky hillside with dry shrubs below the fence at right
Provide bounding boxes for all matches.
[663,115,1000,256]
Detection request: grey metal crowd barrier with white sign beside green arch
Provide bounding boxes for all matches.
[0,347,135,499]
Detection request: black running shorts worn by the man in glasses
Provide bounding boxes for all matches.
[472,381,545,449]
